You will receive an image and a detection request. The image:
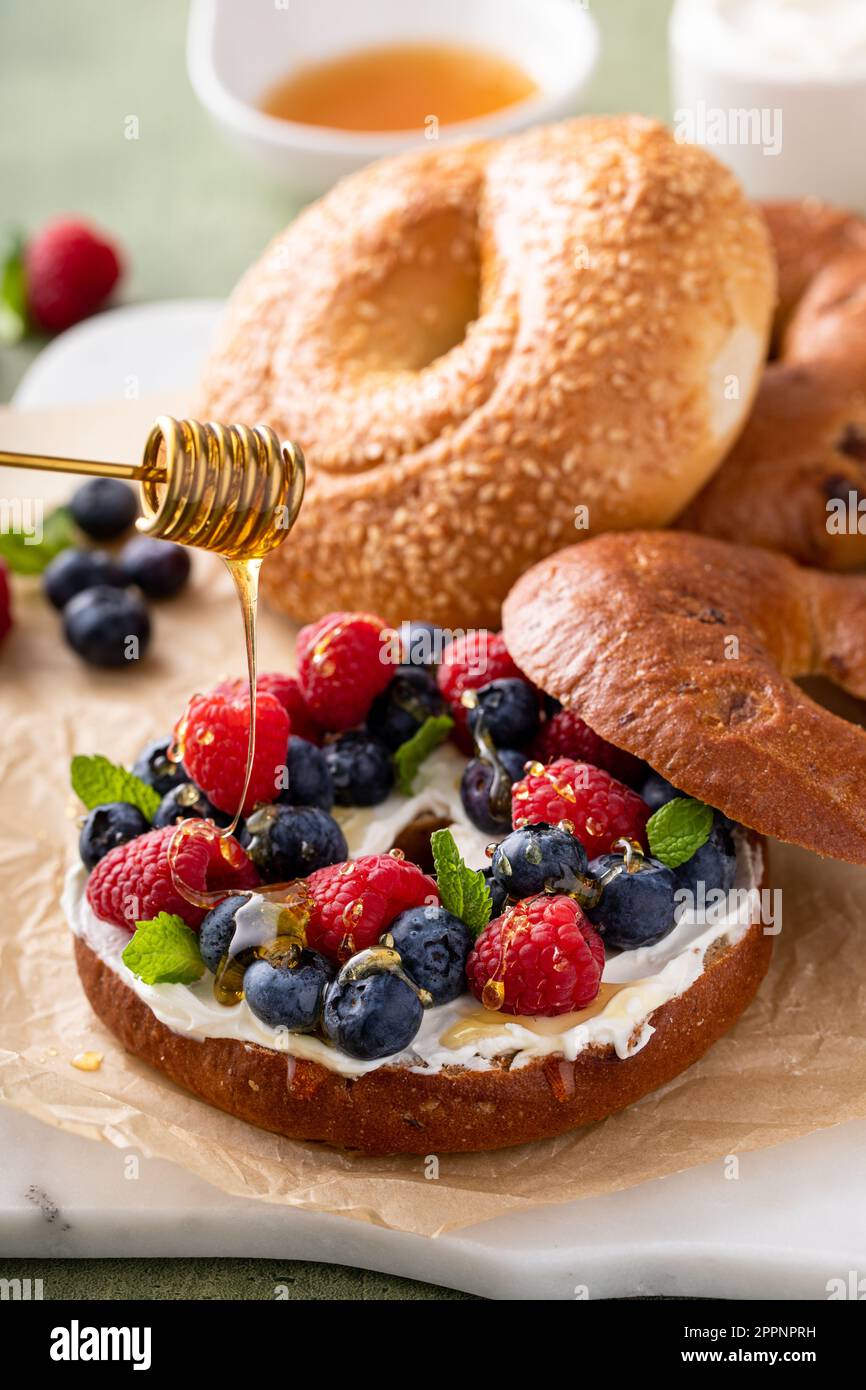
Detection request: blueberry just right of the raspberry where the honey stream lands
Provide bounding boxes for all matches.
[246,805,349,883]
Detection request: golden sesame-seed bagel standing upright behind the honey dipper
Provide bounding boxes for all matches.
[199,117,776,627]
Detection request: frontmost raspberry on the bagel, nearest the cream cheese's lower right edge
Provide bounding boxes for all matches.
[466,894,605,1017]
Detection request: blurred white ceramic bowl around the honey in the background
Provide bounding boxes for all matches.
[186,0,599,195]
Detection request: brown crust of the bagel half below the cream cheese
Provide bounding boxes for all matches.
[75,895,773,1155]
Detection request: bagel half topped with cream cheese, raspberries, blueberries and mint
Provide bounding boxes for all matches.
[64,613,771,1154]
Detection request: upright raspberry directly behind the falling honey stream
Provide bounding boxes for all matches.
[175,692,291,816]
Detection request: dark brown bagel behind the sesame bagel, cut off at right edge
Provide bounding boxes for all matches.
[680,200,866,570]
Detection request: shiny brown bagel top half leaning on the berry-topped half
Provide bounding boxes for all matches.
[503,531,866,865]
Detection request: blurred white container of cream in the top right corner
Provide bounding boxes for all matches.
[670,0,866,210]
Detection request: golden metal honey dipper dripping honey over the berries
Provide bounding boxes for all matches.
[0,416,304,560]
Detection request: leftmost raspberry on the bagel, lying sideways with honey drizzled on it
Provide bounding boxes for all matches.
[88,821,259,931]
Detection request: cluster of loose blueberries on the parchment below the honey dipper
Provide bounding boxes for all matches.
[43,478,189,667]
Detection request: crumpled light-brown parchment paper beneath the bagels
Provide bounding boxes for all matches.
[0,411,866,1236]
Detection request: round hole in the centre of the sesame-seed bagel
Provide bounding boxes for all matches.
[334,209,481,371]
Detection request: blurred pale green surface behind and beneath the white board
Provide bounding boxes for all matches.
[0,0,671,1300]
